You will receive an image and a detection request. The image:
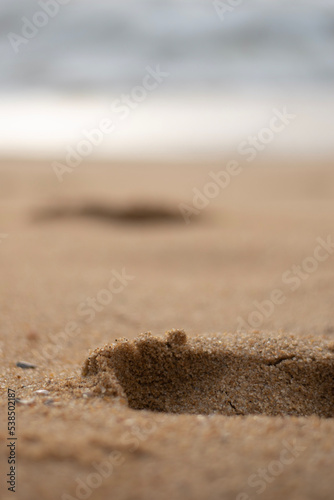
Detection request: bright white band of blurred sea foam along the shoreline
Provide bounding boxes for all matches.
[0,94,334,159]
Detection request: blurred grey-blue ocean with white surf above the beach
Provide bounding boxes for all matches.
[0,0,334,157]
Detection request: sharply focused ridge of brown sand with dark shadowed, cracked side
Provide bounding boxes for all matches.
[82,330,334,417]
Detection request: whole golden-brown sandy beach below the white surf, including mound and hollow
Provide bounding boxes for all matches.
[0,162,334,500]
